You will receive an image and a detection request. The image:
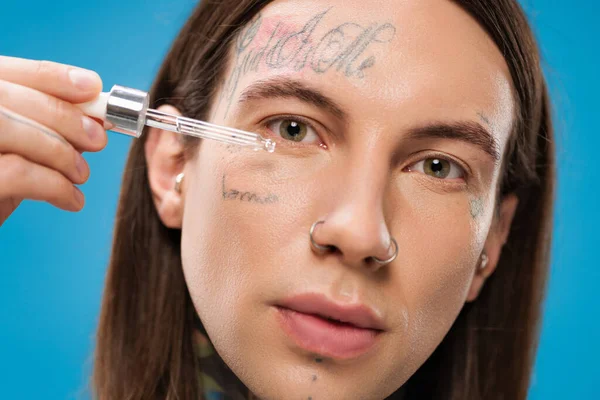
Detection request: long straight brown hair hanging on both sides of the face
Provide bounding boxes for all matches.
[93,0,555,400]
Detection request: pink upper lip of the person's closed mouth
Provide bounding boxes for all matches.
[279,293,385,330]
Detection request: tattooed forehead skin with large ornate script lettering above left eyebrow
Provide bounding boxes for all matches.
[219,10,396,115]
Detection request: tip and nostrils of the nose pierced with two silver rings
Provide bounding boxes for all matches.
[311,192,398,270]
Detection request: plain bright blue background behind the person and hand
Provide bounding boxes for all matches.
[0,0,600,400]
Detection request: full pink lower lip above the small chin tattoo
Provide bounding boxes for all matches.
[277,307,380,360]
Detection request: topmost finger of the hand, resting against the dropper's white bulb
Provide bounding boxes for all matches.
[0,56,102,104]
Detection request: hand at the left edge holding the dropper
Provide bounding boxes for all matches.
[0,56,107,226]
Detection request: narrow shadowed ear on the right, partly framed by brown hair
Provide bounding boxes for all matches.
[466,194,519,302]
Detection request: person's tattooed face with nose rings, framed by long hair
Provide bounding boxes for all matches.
[182,0,514,399]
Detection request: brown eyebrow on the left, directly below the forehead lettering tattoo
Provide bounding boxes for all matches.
[238,77,348,120]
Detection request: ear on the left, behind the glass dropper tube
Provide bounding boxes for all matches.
[144,105,184,229]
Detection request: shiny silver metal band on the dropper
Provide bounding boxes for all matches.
[106,85,149,138]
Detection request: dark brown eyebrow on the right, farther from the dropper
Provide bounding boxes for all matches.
[406,121,501,162]
